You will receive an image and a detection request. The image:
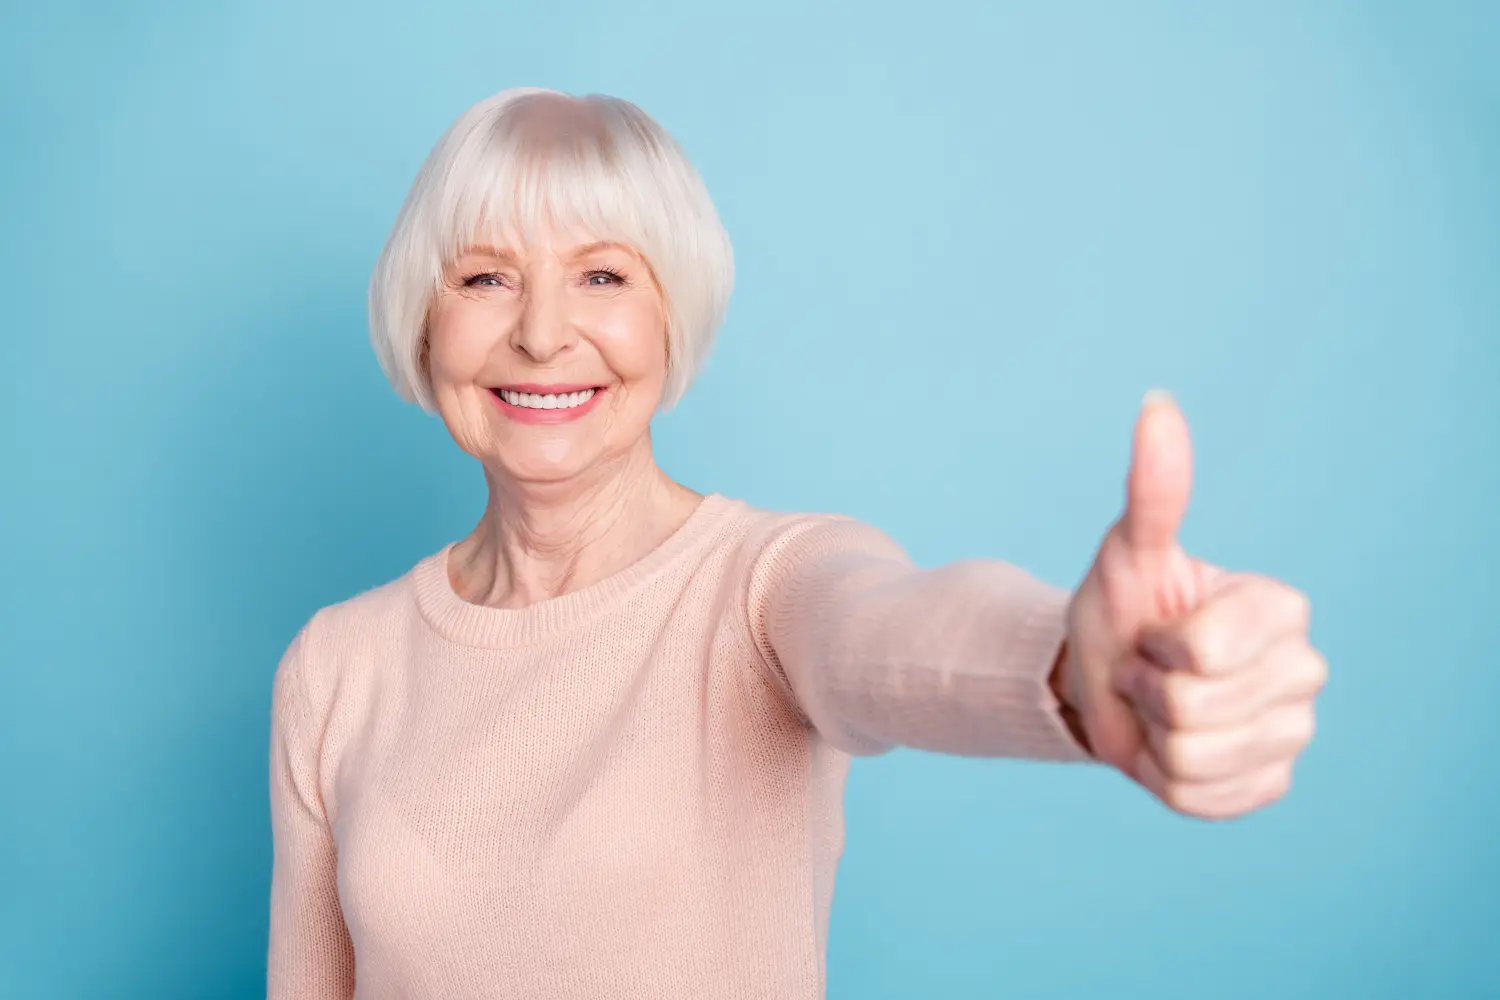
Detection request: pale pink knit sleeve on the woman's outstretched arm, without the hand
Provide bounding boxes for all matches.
[749,516,1089,760]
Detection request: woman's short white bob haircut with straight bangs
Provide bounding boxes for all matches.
[369,87,734,411]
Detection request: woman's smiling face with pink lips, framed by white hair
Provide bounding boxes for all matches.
[428,232,668,483]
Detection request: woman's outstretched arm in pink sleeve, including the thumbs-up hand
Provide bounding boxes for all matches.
[749,396,1328,819]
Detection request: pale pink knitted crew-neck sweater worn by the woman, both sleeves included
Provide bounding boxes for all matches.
[269,493,1086,1000]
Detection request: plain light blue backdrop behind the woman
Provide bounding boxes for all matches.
[0,0,1500,1000]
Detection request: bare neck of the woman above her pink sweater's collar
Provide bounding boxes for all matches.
[449,450,702,607]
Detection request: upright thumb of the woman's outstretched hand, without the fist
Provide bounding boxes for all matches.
[1121,390,1193,552]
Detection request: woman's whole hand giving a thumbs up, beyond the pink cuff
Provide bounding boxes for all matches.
[1055,393,1328,819]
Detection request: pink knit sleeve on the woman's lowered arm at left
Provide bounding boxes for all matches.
[266,628,354,1000]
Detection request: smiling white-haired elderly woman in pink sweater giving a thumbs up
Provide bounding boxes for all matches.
[269,88,1325,1000]
